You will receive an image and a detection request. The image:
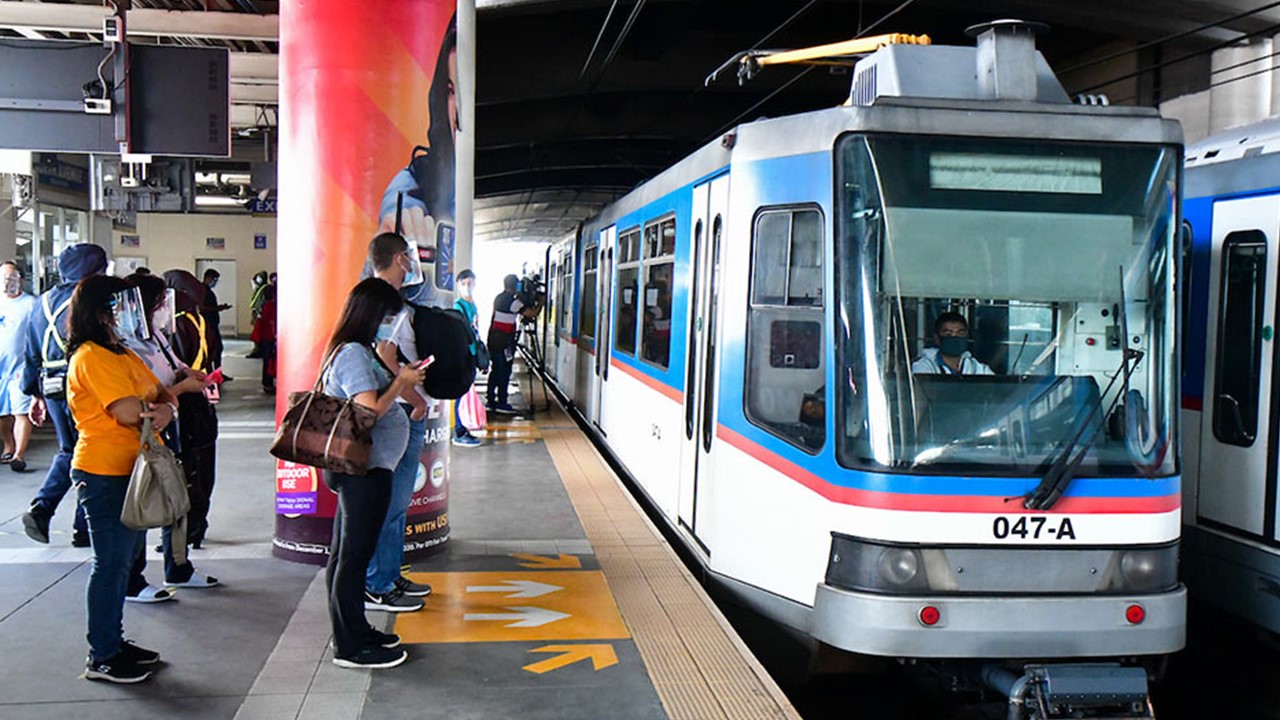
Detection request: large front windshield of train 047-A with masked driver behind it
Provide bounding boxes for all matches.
[835,135,1179,477]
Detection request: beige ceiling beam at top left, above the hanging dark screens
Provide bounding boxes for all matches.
[0,3,280,42]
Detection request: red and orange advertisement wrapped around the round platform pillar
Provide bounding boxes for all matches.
[274,0,468,564]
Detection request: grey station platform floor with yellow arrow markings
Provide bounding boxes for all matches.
[0,343,799,720]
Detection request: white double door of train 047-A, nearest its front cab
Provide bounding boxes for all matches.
[677,176,728,550]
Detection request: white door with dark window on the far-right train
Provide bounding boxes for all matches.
[1198,196,1280,539]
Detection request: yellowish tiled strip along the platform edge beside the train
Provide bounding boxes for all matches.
[535,402,800,720]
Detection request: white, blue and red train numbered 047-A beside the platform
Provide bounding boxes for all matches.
[519,20,1177,717]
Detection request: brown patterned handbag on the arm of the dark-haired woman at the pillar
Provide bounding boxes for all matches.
[264,348,378,475]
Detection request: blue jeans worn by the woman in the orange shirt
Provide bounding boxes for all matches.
[72,470,146,661]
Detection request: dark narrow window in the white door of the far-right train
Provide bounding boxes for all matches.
[1213,231,1267,447]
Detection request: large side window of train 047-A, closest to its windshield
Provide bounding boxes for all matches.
[745,208,827,452]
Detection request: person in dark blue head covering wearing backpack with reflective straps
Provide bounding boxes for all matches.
[22,243,106,547]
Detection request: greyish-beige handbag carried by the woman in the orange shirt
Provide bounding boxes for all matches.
[120,418,191,564]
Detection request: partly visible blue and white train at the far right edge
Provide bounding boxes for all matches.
[1179,118,1280,633]
